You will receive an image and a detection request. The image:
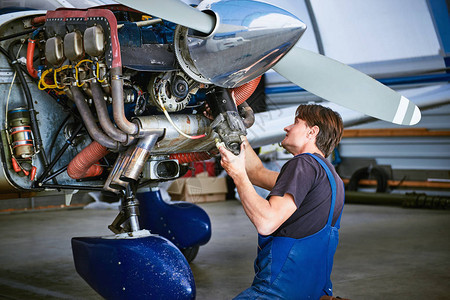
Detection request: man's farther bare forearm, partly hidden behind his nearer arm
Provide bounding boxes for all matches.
[243,137,279,190]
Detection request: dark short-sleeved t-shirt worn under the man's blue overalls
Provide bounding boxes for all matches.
[267,154,344,239]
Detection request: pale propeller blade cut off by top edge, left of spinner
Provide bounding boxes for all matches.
[116,0,216,34]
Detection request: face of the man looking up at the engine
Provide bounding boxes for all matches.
[281,118,309,155]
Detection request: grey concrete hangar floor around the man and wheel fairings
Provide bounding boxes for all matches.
[0,201,450,300]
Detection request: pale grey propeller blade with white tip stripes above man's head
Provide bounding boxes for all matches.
[273,47,421,125]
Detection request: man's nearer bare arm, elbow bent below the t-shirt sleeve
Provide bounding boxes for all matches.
[219,143,297,235]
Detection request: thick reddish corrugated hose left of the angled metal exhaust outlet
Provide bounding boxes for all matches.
[67,141,109,179]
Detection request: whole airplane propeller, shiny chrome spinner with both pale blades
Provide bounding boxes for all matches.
[118,0,421,125]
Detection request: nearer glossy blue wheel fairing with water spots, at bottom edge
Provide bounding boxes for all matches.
[72,236,195,300]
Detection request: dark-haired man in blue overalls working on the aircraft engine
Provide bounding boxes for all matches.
[219,105,344,299]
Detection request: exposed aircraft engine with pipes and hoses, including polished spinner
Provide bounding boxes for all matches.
[0,3,284,194]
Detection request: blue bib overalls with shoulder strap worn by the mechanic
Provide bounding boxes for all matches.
[234,153,342,300]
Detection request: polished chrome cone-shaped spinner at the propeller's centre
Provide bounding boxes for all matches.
[175,0,306,88]
